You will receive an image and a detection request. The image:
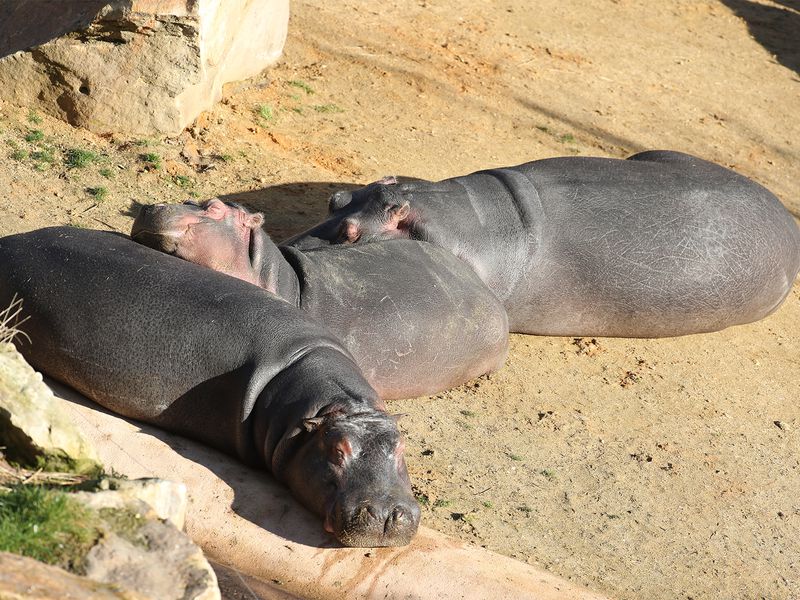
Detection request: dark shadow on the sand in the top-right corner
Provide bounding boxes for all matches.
[722,0,800,73]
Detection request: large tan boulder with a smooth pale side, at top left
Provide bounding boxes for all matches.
[0,0,289,135]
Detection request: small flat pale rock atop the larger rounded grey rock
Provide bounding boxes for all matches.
[74,478,188,530]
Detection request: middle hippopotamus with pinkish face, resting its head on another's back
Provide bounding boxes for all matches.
[131,198,508,399]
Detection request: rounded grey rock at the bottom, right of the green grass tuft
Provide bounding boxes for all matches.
[86,520,220,600]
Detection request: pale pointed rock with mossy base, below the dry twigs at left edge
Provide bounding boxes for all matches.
[0,344,101,474]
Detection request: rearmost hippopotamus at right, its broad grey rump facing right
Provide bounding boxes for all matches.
[282,150,800,337]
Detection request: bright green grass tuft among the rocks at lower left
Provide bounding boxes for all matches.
[0,485,98,573]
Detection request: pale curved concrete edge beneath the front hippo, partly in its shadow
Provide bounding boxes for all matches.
[53,382,603,600]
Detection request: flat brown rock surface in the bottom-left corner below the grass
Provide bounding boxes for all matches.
[0,552,145,600]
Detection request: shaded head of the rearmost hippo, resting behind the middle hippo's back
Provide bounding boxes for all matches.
[283,177,423,250]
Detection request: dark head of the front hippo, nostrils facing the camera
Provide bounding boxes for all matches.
[280,411,420,547]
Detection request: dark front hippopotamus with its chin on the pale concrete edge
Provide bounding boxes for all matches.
[0,227,420,546]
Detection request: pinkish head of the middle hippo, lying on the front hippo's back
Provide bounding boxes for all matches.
[131,198,293,302]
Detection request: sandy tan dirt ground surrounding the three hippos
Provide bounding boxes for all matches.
[0,0,800,599]
